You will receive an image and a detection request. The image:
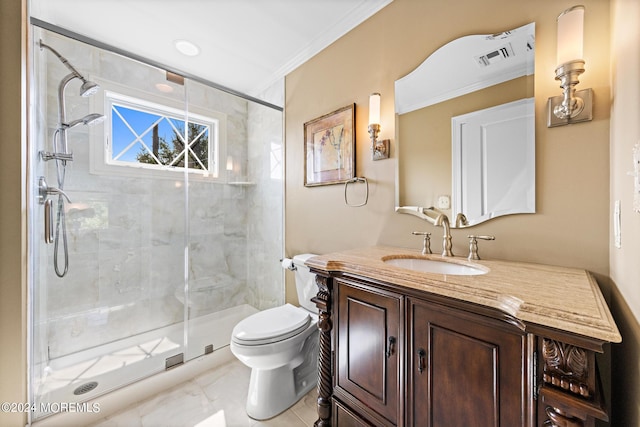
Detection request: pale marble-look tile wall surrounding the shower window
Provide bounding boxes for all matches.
[36,31,284,358]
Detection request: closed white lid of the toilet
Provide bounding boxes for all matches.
[233,304,311,345]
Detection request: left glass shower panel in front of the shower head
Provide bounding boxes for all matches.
[29,28,188,416]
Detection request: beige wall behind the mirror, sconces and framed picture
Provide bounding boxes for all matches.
[285,0,610,294]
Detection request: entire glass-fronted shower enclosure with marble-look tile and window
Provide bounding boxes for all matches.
[28,26,284,416]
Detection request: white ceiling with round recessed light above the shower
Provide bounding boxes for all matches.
[30,0,392,105]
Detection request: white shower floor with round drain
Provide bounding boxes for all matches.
[36,304,258,415]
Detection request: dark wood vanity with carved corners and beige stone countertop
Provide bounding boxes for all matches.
[307,247,621,427]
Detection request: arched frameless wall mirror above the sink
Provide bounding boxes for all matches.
[395,23,535,227]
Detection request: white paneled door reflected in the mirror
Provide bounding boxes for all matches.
[451,98,535,225]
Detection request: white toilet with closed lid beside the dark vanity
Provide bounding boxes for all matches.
[231,254,318,420]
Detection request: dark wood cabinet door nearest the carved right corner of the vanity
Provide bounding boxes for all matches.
[407,300,529,427]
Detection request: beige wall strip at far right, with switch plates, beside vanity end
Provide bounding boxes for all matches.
[609,0,640,426]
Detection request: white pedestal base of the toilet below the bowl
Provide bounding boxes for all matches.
[247,334,318,420]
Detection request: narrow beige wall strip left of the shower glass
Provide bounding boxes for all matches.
[0,0,27,426]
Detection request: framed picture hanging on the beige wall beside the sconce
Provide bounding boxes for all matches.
[304,104,356,187]
